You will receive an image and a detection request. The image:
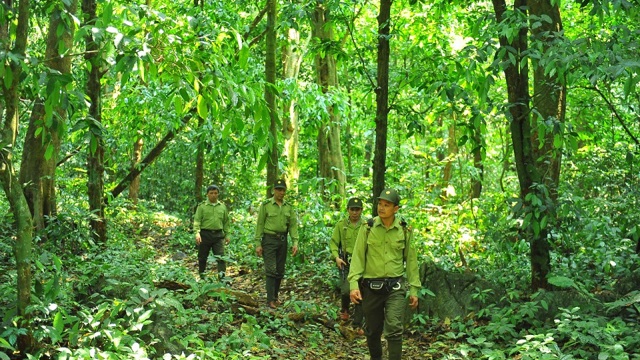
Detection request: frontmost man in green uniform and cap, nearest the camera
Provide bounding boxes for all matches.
[349,189,422,360]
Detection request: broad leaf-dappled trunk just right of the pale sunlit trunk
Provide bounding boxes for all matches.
[312,2,346,209]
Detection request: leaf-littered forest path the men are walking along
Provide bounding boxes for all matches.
[168,249,447,360]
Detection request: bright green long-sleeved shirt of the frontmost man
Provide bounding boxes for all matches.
[348,217,422,296]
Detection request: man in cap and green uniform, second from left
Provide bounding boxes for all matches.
[255,180,298,309]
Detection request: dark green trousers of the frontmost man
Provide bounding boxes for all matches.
[361,286,407,360]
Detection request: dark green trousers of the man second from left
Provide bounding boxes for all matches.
[262,234,288,303]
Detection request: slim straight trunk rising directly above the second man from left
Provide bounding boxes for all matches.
[264,0,279,197]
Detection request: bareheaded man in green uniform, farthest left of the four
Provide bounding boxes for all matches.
[193,185,229,280]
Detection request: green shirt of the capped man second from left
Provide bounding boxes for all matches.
[255,197,298,246]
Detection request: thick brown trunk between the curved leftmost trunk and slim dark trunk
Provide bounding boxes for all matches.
[20,0,77,230]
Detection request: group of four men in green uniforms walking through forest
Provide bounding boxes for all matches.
[193,180,422,360]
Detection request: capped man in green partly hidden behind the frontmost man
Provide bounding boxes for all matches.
[329,197,364,327]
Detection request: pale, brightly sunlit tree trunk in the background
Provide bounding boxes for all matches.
[282,28,303,192]
